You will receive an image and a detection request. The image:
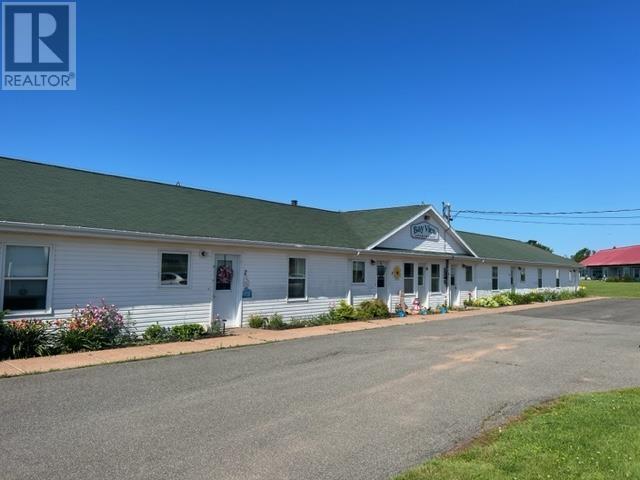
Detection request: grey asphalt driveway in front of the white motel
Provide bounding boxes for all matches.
[0,300,640,480]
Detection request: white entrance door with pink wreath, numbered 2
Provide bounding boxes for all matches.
[213,253,240,327]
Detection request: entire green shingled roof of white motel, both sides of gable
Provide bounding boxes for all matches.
[0,157,574,265]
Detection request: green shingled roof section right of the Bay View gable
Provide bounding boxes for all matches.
[457,230,578,267]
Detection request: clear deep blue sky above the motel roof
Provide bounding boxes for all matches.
[0,0,640,254]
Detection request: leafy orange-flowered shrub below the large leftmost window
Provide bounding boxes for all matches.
[3,320,53,358]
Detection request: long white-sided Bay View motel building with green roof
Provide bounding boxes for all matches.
[0,158,579,329]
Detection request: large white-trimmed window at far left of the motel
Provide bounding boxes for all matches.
[0,245,51,312]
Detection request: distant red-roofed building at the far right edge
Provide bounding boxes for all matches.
[580,245,640,280]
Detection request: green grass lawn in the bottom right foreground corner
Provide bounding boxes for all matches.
[396,389,640,480]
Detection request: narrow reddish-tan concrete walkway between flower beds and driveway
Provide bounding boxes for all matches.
[0,297,601,377]
